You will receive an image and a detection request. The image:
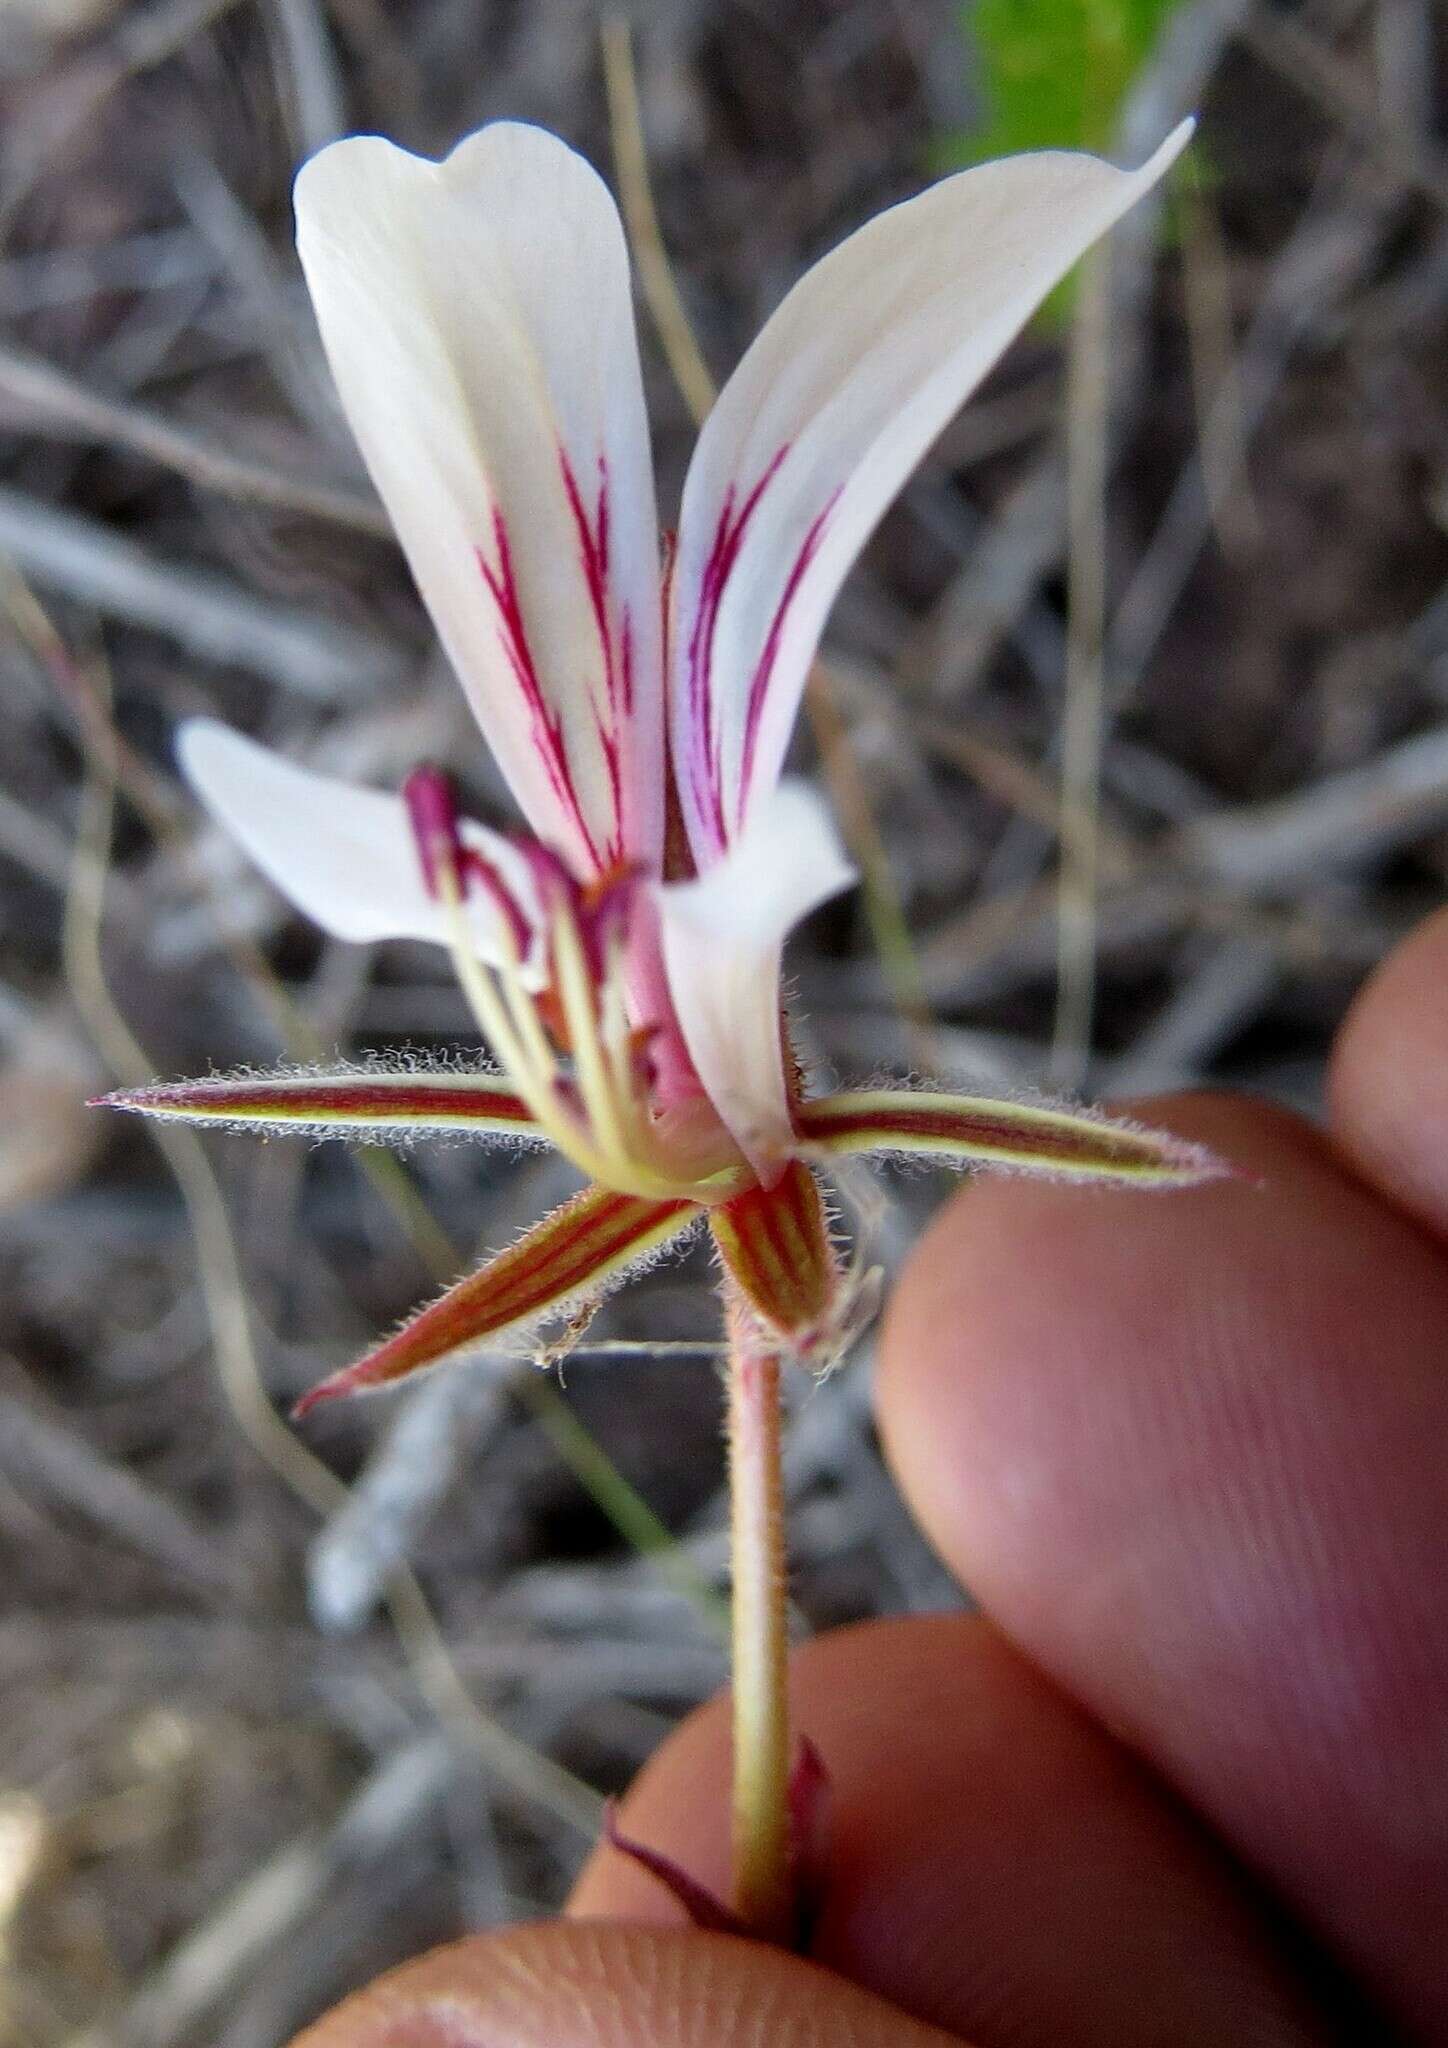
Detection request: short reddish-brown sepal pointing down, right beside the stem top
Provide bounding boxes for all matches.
[709,1159,842,1356]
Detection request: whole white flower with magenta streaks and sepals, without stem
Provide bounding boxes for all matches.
[101,103,1210,1386]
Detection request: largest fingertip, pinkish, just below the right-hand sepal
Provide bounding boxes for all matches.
[879,1089,1448,2030]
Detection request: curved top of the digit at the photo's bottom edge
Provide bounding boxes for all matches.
[293,1921,961,2048]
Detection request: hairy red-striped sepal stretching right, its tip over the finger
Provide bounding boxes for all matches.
[795,1087,1231,1188]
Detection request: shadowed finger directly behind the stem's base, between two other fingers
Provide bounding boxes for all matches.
[569,1614,1321,2048]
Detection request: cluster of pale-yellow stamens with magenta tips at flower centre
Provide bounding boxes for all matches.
[403,768,748,1202]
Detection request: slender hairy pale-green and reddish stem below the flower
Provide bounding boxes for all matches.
[727,1309,795,1942]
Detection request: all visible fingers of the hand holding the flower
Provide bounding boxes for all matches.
[290,913,1448,2048]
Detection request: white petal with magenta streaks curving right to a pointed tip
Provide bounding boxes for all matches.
[670,123,1190,868]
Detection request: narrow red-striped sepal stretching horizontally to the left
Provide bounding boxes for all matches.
[94,1067,541,1139]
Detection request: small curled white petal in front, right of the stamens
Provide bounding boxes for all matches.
[655,782,856,1180]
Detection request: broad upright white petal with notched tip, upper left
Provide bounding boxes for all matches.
[295,123,664,874]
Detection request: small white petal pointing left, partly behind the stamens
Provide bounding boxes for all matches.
[176,719,539,963]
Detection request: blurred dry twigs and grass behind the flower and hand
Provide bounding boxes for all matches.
[0,0,1448,2048]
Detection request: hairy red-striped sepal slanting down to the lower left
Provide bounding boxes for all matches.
[293,1188,700,1419]
